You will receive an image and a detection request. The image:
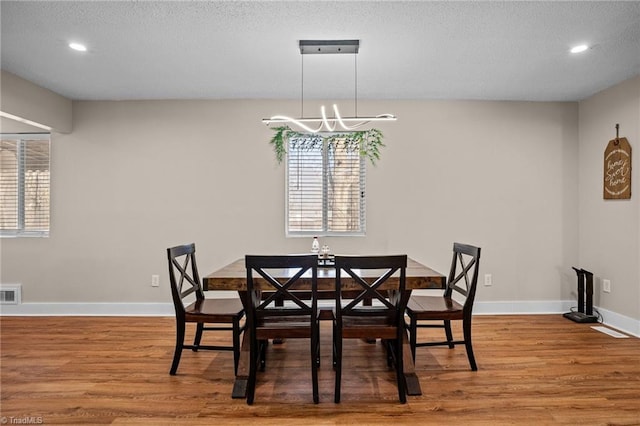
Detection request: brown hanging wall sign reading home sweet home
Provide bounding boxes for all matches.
[604,133,631,199]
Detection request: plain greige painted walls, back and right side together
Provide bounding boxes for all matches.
[0,77,640,334]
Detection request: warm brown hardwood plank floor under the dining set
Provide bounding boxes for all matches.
[0,315,640,425]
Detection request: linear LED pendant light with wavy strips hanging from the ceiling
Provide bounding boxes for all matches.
[262,40,396,133]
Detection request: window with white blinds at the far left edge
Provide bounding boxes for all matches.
[0,134,50,237]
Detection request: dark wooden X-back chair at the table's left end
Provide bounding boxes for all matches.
[167,243,244,375]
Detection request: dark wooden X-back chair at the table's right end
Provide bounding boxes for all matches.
[406,243,480,371]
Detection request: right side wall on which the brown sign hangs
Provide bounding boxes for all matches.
[579,77,640,322]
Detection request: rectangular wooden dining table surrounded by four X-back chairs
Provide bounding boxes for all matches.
[202,258,446,398]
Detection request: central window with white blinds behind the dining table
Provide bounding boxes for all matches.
[286,134,365,235]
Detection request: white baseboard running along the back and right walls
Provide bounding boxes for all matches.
[0,300,640,337]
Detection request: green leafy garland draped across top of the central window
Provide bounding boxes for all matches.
[269,126,385,166]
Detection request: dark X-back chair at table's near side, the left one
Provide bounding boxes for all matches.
[245,254,320,405]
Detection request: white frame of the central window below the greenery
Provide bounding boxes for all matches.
[284,132,366,237]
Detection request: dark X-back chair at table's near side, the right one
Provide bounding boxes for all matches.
[333,255,408,404]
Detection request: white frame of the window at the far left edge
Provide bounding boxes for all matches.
[0,132,51,238]
